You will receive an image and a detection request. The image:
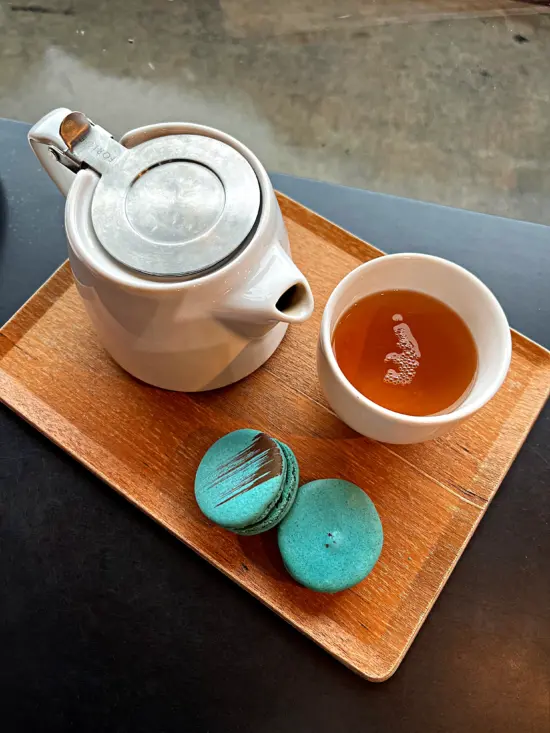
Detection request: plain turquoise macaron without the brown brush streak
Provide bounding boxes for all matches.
[278,479,384,593]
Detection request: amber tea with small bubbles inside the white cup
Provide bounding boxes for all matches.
[332,290,477,416]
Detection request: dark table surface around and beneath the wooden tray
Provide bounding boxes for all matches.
[0,121,550,733]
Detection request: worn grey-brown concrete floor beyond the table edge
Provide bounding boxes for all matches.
[0,0,550,224]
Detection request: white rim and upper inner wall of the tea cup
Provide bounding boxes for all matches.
[320,252,512,427]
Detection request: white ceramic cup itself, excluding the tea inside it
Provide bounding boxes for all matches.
[317,254,512,443]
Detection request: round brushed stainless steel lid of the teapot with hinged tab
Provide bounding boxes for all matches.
[52,112,260,277]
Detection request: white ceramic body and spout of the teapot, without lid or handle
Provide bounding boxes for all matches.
[31,114,313,392]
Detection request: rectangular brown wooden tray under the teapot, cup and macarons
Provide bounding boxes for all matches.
[0,196,550,681]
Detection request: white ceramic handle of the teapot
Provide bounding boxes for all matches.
[28,107,79,196]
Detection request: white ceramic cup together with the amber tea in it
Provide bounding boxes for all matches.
[318,254,511,443]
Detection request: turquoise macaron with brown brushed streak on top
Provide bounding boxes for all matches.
[195,429,299,535]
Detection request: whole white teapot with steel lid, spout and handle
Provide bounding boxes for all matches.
[29,108,313,392]
